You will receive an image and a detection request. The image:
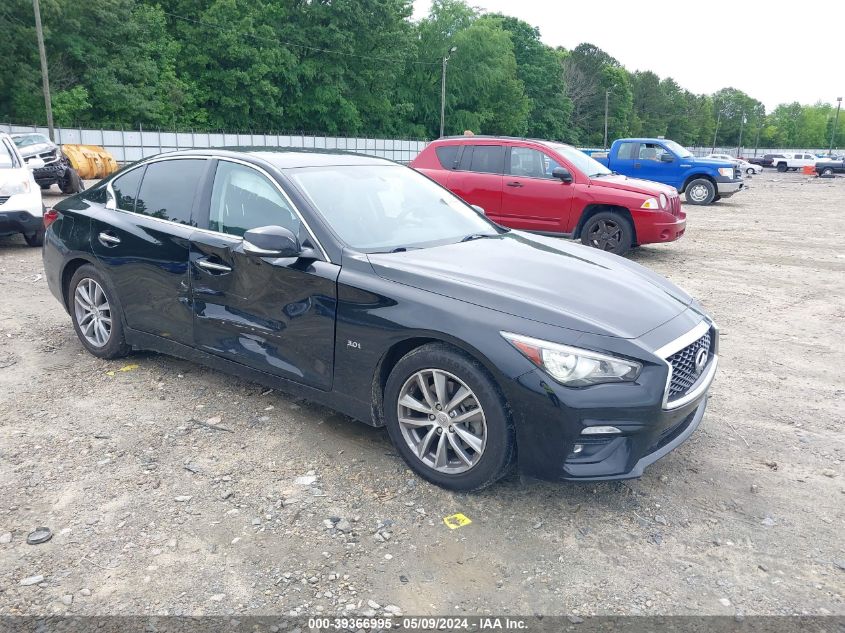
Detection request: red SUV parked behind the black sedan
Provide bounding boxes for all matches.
[411,136,686,255]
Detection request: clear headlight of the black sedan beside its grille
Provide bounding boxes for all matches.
[501,332,642,387]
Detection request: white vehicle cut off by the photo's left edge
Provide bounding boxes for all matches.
[0,134,44,246]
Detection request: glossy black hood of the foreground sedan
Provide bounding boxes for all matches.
[368,231,692,338]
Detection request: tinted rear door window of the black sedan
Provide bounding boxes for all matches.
[135,159,206,225]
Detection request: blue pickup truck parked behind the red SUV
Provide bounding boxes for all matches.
[592,138,744,204]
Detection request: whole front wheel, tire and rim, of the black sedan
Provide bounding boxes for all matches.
[384,343,515,491]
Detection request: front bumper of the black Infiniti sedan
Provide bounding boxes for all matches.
[506,314,718,481]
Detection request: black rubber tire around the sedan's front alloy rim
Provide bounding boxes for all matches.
[384,343,516,492]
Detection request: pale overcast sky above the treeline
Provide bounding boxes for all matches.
[414,0,845,112]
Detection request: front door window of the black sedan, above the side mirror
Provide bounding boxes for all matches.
[208,160,298,235]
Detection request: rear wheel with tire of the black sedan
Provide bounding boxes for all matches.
[68,264,131,358]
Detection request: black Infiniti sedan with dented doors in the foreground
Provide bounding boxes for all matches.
[44,150,718,490]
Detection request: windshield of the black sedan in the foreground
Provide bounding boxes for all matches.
[288,165,500,252]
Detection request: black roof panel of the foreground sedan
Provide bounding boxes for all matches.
[156,147,397,169]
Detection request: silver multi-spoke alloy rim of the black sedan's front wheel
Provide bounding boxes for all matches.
[397,369,487,475]
